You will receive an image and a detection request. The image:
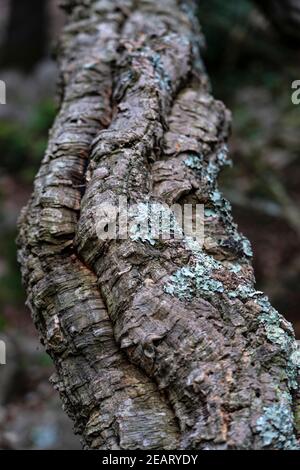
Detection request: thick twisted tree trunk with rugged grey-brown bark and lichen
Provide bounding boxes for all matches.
[19,0,299,449]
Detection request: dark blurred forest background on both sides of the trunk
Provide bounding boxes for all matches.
[0,0,300,449]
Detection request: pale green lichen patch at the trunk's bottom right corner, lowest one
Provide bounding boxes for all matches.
[256,395,299,450]
